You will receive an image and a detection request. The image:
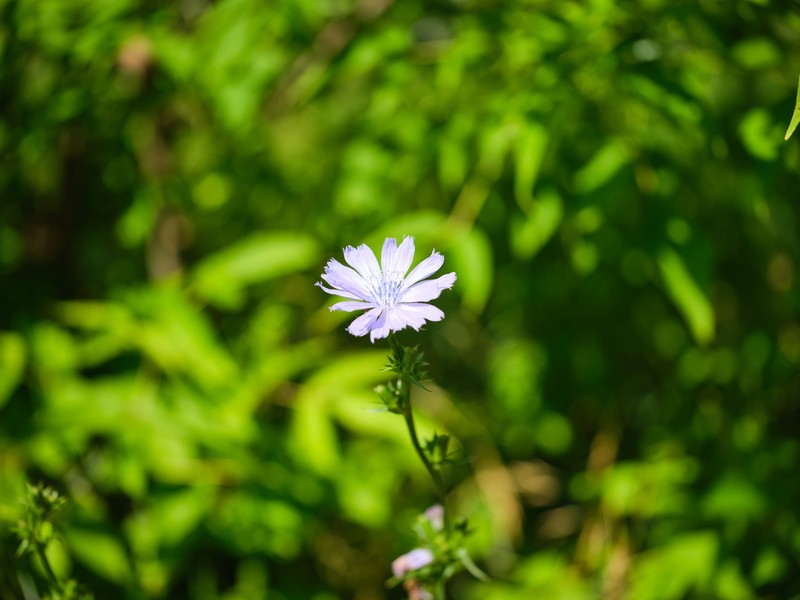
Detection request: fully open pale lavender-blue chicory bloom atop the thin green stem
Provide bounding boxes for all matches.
[317,237,456,342]
